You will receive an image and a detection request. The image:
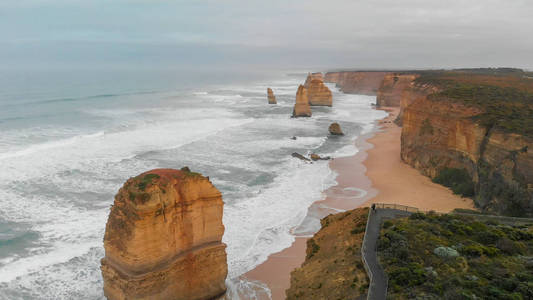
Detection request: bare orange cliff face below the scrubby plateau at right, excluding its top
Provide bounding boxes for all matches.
[401,85,533,215]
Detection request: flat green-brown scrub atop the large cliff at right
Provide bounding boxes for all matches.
[415,68,533,137]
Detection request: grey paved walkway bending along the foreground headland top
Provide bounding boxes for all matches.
[363,208,412,300]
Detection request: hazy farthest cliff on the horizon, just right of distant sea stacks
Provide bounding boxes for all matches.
[324,71,388,95]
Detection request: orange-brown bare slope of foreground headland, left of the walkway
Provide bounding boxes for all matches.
[286,208,369,299]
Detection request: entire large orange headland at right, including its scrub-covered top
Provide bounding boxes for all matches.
[401,70,533,216]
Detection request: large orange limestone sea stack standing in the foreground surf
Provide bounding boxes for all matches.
[101,168,228,300]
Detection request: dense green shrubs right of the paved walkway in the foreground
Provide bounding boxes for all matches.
[378,213,533,299]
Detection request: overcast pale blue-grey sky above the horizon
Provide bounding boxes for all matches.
[0,0,533,69]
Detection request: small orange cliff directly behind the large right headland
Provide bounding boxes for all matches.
[376,73,418,107]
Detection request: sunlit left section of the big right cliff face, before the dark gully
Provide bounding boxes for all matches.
[401,97,486,177]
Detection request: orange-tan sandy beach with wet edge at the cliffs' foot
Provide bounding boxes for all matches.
[244,108,474,300]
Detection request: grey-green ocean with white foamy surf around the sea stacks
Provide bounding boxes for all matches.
[0,70,385,299]
